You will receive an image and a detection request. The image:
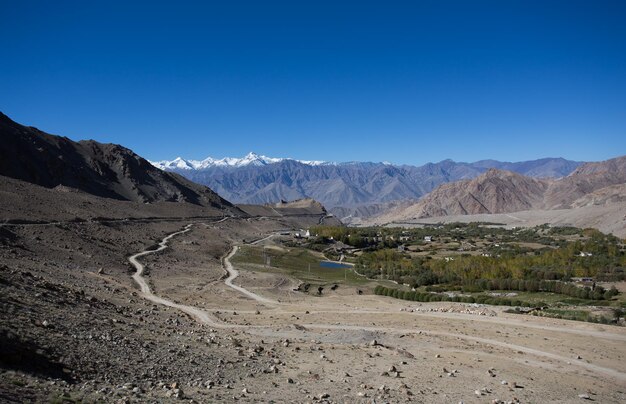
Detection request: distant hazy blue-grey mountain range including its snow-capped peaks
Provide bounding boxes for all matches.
[152,153,581,218]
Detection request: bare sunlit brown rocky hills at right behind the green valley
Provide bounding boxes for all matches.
[376,156,626,223]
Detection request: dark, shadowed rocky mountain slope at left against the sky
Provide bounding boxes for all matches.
[0,113,232,207]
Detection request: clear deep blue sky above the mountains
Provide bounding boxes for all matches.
[0,0,626,164]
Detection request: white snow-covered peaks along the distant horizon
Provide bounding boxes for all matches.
[150,152,326,170]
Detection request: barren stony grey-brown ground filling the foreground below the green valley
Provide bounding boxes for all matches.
[0,219,626,403]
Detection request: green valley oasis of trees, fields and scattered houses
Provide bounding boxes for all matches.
[298,223,626,324]
